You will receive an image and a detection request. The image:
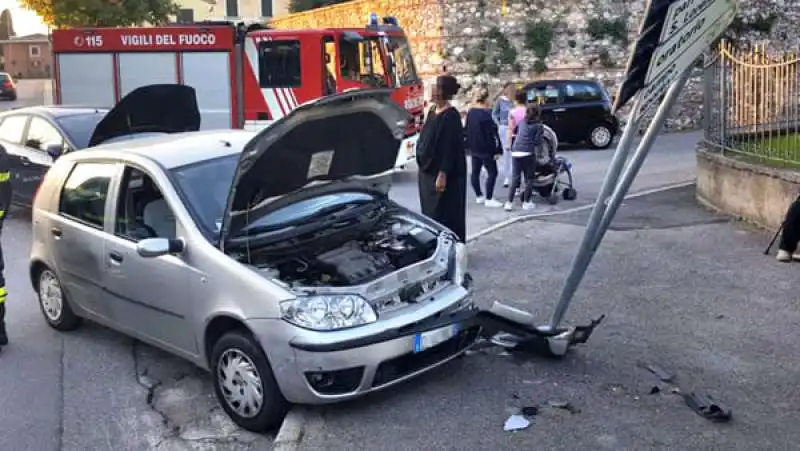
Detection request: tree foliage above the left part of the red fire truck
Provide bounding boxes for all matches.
[20,0,179,28]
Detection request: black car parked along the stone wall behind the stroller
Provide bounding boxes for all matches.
[522,80,619,149]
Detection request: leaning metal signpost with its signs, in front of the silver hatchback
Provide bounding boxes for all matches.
[548,0,736,330]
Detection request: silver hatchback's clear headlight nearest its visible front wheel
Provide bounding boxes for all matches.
[281,294,378,331]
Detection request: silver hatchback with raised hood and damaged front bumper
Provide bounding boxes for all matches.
[30,90,479,431]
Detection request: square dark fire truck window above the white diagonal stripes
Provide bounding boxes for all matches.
[258,41,300,88]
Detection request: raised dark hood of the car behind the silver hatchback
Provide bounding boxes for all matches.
[89,85,200,147]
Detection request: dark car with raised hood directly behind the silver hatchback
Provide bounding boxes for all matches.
[0,85,199,206]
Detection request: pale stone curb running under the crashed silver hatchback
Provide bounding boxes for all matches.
[273,180,696,451]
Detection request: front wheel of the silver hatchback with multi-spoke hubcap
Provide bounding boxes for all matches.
[211,331,289,432]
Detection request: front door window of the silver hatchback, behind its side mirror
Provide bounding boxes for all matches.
[114,166,176,242]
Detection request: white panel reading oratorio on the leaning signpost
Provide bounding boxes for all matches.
[645,0,736,85]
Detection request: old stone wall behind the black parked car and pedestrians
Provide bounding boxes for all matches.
[273,0,800,131]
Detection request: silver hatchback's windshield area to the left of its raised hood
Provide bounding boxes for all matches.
[170,154,239,240]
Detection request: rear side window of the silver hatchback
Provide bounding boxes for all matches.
[58,163,117,229]
